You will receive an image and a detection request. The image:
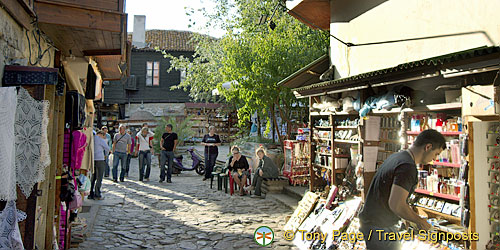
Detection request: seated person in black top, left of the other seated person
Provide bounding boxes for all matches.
[226,145,250,196]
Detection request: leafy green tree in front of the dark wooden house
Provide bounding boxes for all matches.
[166,0,328,145]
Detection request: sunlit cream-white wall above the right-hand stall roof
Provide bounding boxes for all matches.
[330,0,500,78]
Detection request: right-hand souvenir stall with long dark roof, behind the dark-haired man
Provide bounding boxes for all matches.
[285,47,500,249]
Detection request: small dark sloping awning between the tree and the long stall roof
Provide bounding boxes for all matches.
[278,55,330,89]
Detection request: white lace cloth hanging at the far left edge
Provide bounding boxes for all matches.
[0,87,17,200]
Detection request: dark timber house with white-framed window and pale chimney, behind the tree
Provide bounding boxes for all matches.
[102,16,194,126]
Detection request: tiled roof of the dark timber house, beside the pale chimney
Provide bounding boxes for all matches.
[127,30,195,52]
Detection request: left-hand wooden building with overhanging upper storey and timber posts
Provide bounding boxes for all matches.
[0,0,130,249]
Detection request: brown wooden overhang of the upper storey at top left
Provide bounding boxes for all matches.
[34,0,127,80]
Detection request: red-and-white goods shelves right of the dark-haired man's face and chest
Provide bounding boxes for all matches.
[401,104,472,248]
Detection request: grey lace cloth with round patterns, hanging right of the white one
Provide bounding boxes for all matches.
[14,88,50,197]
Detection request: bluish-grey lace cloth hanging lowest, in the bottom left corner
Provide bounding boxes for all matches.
[0,200,26,250]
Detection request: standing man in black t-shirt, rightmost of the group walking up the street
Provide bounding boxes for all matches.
[160,124,178,183]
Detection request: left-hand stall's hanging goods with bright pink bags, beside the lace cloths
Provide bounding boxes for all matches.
[59,58,98,249]
